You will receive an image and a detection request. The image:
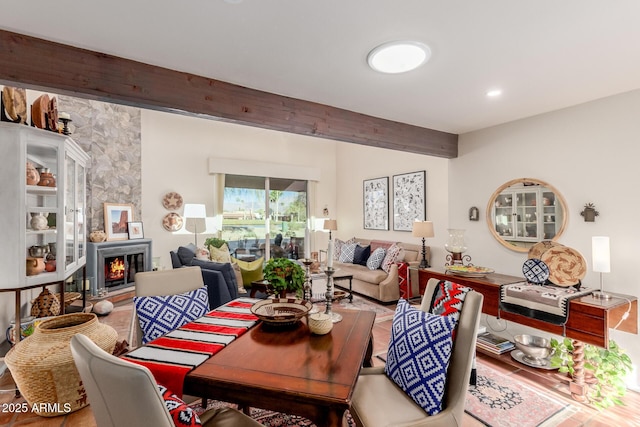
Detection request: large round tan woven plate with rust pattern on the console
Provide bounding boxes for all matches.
[540,245,587,286]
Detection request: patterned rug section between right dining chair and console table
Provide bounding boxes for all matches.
[465,363,573,427]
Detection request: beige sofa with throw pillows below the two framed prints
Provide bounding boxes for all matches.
[333,237,429,303]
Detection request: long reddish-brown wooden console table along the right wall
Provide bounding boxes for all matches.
[418,268,638,348]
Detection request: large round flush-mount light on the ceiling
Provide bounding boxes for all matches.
[367,41,431,74]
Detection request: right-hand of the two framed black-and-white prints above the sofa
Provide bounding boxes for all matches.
[393,171,427,231]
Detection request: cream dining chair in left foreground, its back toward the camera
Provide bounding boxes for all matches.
[70,334,262,427]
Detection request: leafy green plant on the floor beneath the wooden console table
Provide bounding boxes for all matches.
[550,338,632,409]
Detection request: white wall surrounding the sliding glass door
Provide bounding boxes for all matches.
[142,110,337,268]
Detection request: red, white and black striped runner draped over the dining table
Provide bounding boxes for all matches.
[122,298,259,396]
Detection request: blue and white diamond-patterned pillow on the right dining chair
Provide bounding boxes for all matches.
[384,299,456,415]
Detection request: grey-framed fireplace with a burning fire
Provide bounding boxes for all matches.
[87,239,152,296]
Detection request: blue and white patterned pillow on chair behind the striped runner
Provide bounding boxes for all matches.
[133,286,209,344]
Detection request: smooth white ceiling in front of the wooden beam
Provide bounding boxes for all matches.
[0,0,640,133]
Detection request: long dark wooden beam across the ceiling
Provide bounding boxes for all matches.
[0,30,458,158]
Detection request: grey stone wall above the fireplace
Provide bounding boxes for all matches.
[58,95,142,233]
